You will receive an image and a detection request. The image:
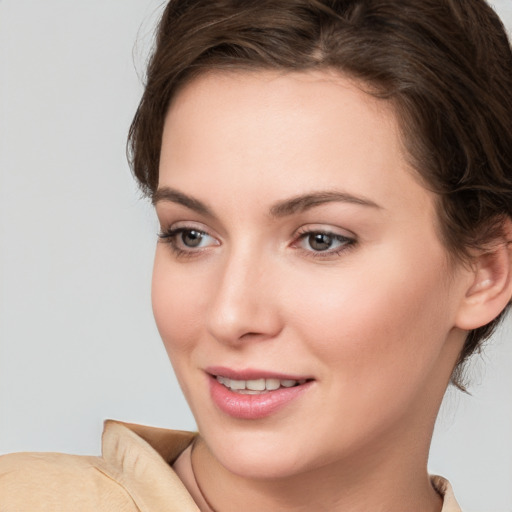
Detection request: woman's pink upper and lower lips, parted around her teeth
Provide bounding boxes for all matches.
[207,367,313,420]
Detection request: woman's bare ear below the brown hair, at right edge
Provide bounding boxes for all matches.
[456,218,512,331]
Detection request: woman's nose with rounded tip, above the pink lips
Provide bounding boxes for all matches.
[206,246,282,345]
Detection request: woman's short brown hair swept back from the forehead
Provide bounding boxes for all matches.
[128,0,512,389]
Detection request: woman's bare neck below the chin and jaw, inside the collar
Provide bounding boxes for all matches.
[186,426,442,512]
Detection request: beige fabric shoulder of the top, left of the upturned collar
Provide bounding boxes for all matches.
[0,453,138,512]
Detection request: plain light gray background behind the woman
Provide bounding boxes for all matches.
[0,0,512,512]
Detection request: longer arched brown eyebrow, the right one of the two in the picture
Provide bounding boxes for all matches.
[270,191,382,217]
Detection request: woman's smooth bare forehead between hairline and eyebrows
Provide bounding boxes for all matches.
[160,67,431,218]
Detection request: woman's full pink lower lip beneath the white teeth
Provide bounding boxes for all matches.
[210,377,312,420]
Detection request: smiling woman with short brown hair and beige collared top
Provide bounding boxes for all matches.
[0,0,512,512]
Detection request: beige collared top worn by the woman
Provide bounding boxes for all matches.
[0,420,461,512]
